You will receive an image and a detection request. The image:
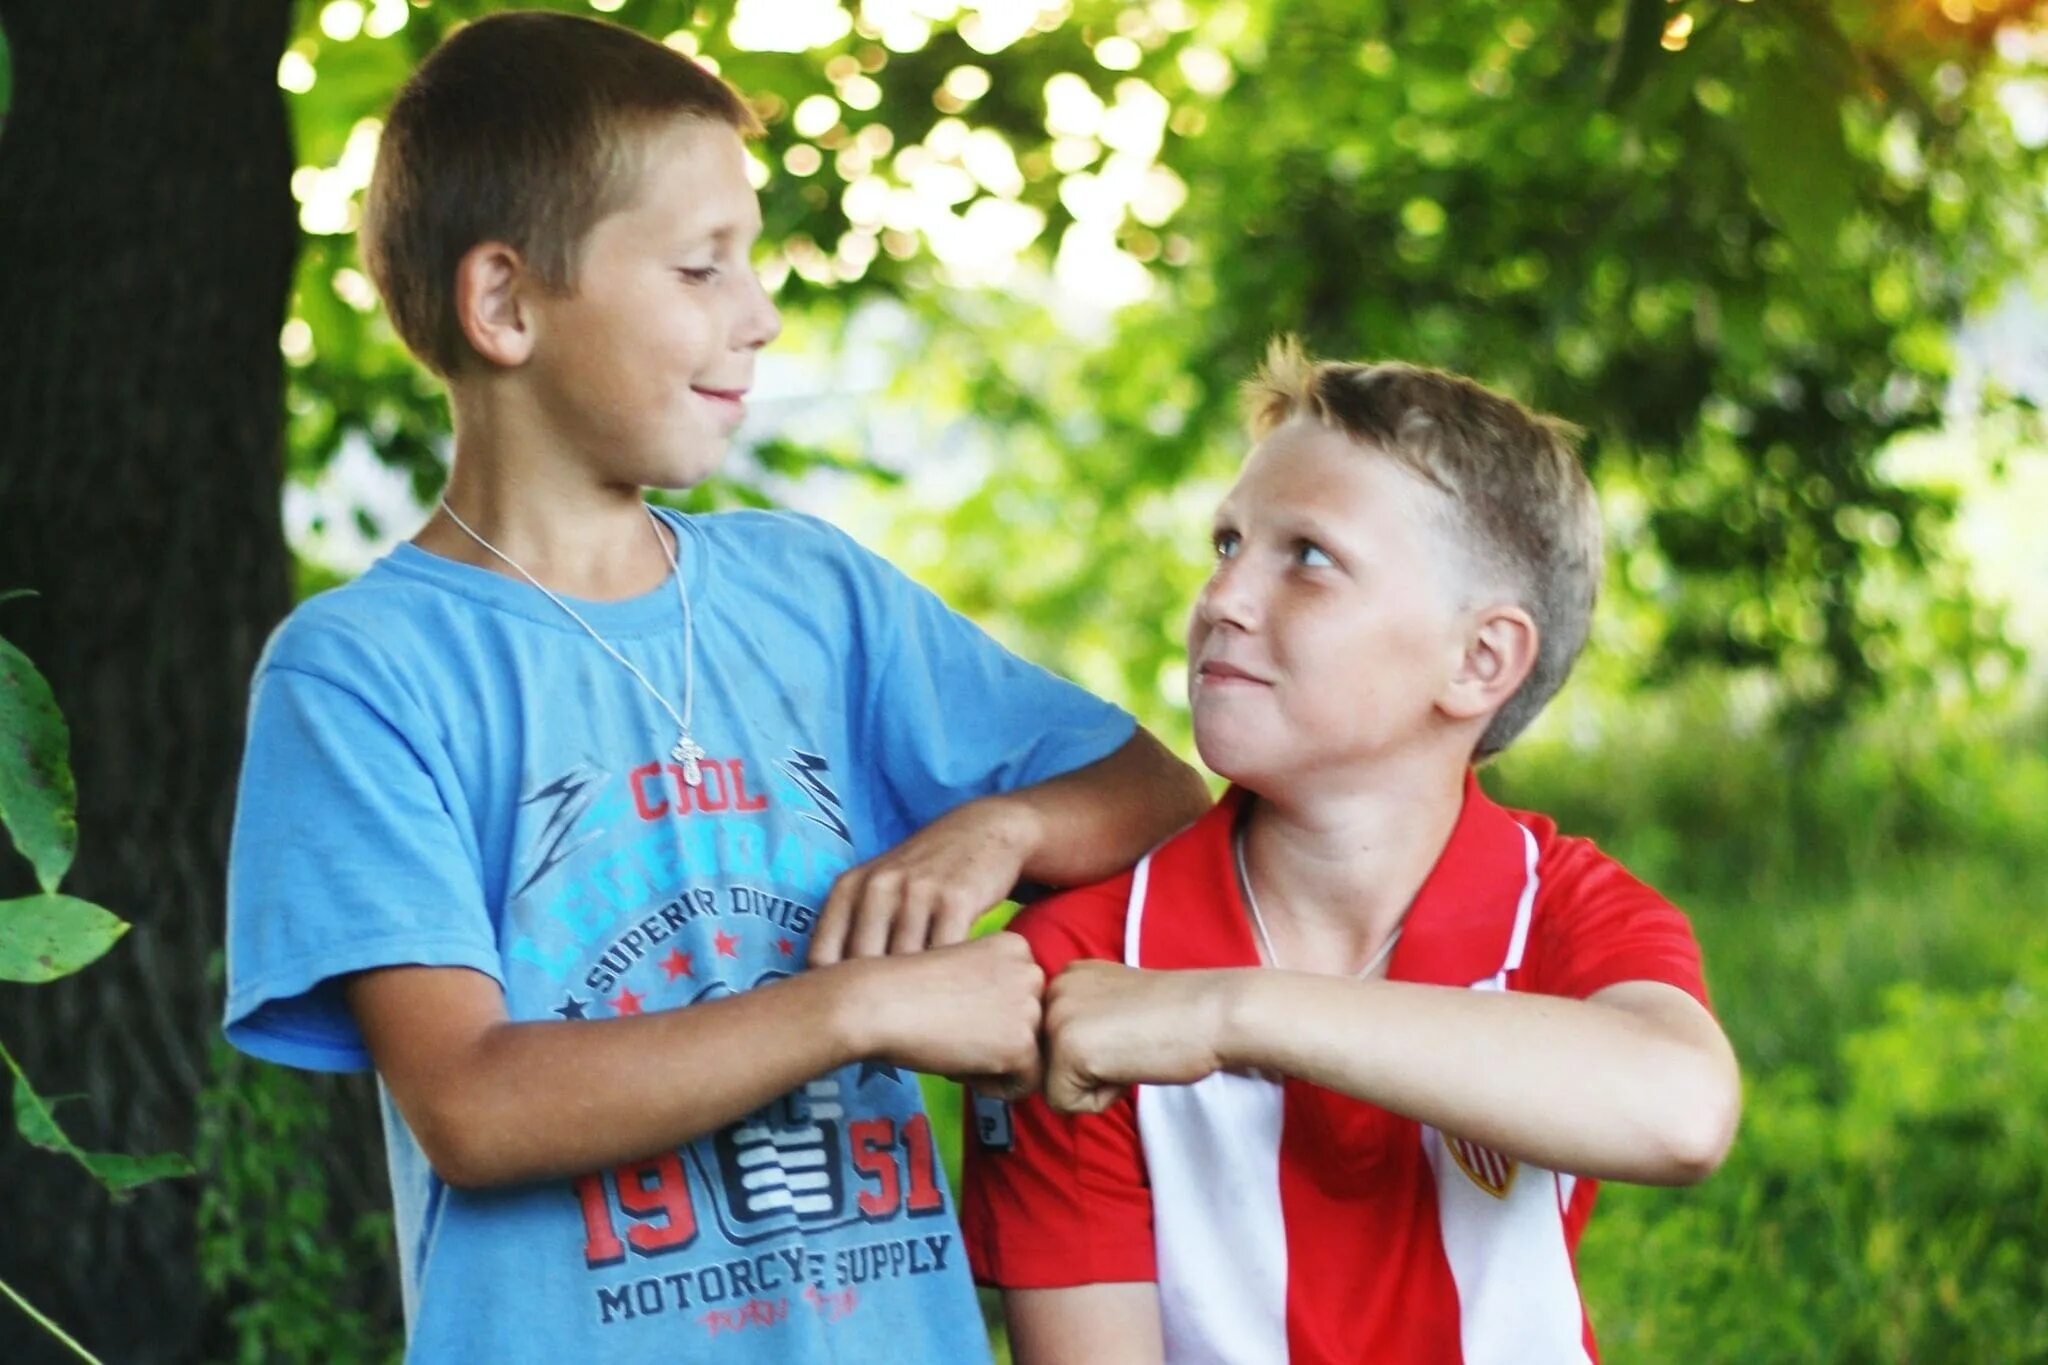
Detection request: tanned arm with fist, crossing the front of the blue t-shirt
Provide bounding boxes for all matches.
[346,933,1044,1185]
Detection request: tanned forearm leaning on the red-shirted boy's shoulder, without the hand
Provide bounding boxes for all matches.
[993,729,1208,886]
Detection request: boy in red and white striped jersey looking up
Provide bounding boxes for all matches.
[963,344,1739,1365]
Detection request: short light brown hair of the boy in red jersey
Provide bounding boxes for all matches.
[1245,338,1602,759]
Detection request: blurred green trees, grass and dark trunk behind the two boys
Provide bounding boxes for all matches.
[0,0,2048,1363]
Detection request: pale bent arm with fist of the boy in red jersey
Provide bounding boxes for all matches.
[1047,962,1741,1185]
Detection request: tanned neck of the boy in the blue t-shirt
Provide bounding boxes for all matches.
[414,388,674,602]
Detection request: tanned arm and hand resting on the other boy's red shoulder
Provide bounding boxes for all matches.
[811,731,1208,966]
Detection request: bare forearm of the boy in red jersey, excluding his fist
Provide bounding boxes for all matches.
[1219,970,1739,1185]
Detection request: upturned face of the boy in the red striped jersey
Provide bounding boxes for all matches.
[1188,420,1473,796]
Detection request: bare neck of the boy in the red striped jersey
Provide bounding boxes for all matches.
[1245,763,1466,970]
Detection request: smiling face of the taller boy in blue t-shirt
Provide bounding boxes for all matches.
[528,119,782,489]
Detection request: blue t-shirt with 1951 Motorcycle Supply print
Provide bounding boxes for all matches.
[225,512,1133,1365]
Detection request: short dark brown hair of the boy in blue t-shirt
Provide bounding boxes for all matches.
[358,10,760,377]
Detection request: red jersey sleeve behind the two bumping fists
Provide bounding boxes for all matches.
[961,876,1157,1289]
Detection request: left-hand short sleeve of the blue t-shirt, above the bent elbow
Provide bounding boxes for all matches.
[225,665,502,1070]
